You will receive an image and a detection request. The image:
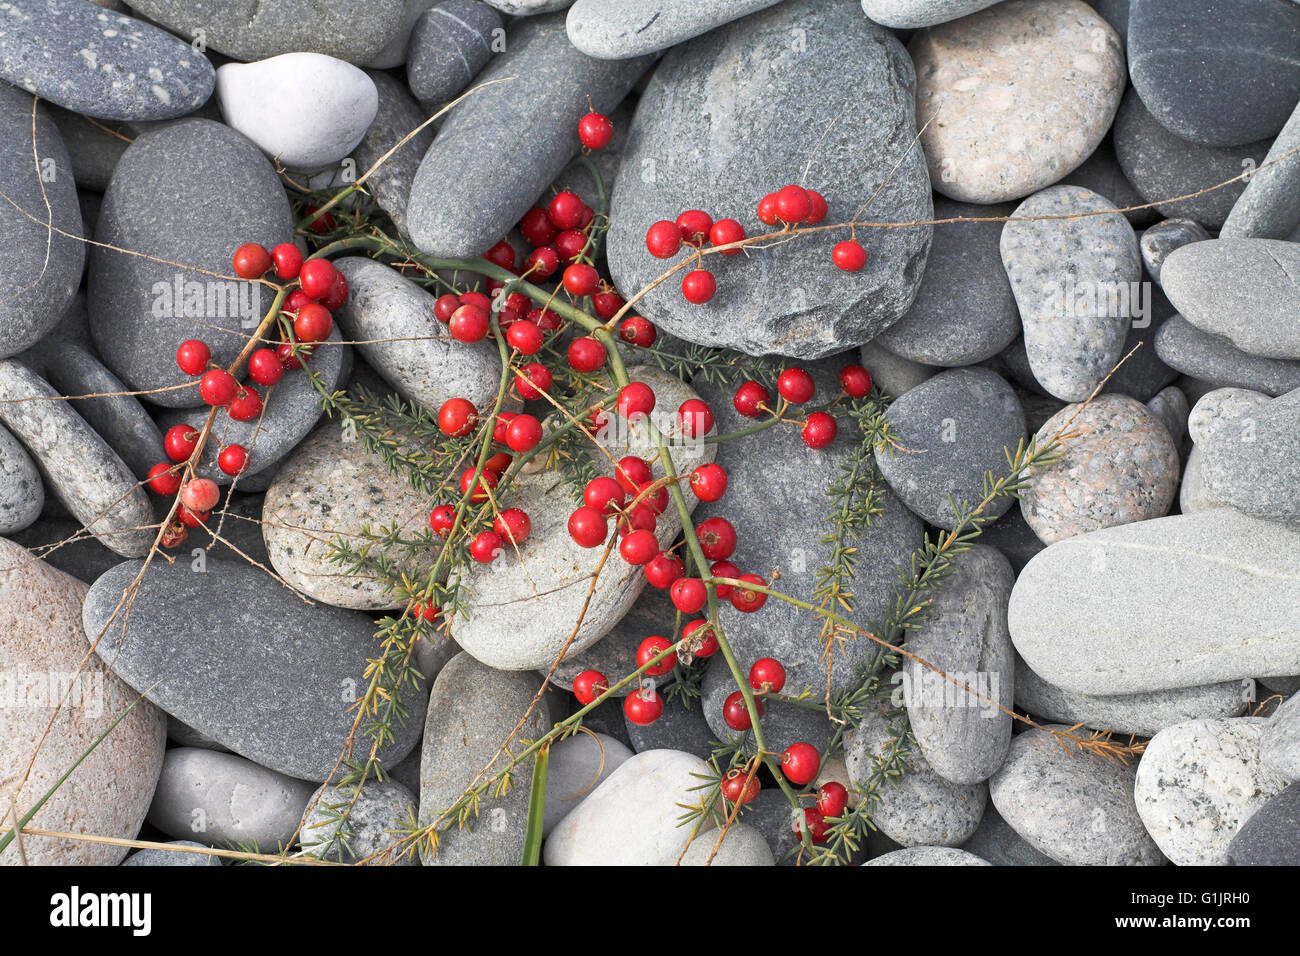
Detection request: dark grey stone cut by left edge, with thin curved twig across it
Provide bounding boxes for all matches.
[0,83,86,358]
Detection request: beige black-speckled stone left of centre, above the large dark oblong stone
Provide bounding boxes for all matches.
[261,421,438,611]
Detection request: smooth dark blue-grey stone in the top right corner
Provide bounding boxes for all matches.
[1128,0,1300,146]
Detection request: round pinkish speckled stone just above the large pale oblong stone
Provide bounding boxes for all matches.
[1021,394,1182,545]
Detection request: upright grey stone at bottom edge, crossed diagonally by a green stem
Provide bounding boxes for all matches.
[420,654,551,866]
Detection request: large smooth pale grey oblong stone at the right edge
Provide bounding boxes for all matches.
[1008,509,1300,695]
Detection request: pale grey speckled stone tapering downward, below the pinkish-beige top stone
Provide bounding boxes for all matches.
[1001,186,1141,402]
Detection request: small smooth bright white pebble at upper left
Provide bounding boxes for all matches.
[217,53,380,169]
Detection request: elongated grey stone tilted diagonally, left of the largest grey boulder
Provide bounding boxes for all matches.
[407,14,650,256]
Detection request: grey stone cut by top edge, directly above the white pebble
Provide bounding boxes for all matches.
[127,0,406,64]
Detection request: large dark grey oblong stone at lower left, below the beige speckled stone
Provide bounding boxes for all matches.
[83,558,425,780]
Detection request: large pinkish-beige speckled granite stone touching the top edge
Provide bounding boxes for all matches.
[909,0,1126,203]
